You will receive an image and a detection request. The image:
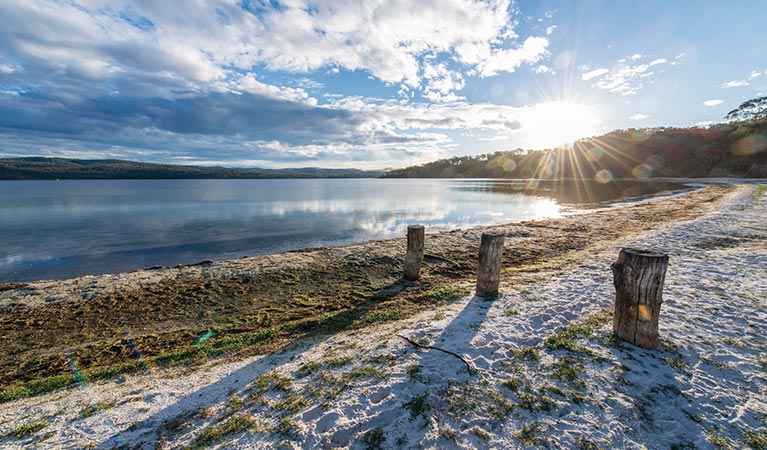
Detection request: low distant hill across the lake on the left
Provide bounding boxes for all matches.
[0,157,383,180]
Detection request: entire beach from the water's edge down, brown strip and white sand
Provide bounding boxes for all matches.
[0,185,767,449]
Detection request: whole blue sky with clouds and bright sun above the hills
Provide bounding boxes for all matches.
[0,0,767,169]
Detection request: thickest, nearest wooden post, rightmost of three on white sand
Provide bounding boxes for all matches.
[610,248,668,350]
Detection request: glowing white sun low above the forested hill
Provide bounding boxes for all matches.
[520,101,601,148]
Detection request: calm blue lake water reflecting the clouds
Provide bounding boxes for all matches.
[0,179,688,282]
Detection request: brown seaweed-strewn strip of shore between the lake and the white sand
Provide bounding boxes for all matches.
[0,185,739,391]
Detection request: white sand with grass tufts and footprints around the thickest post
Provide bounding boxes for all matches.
[0,186,767,449]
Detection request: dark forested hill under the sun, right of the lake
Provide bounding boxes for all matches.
[384,111,767,180]
